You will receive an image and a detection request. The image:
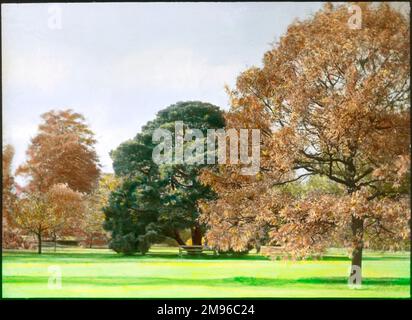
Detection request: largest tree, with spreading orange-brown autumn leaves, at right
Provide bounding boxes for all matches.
[200,4,410,282]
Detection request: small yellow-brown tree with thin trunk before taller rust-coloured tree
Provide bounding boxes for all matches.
[16,184,84,254]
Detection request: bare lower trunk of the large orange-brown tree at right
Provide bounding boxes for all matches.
[349,216,363,285]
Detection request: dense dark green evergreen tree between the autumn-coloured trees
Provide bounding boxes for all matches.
[105,101,225,253]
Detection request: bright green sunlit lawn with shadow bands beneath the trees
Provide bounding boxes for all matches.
[2,248,410,298]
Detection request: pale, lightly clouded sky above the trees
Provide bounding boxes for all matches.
[1,2,332,176]
